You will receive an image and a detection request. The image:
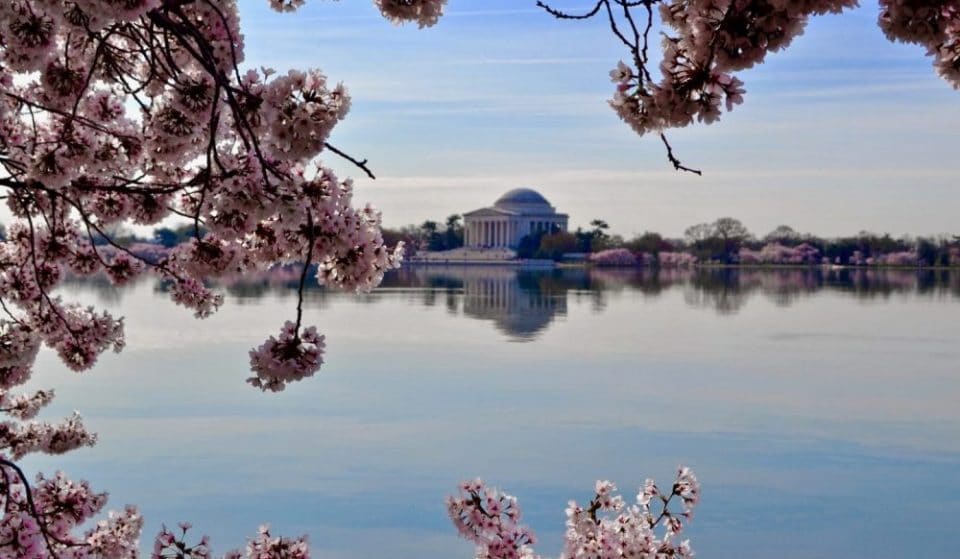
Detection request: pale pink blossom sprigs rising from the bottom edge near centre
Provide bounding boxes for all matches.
[447,466,700,559]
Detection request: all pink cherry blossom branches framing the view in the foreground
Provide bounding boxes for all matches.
[0,0,960,559]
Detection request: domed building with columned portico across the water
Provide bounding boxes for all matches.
[463,188,569,248]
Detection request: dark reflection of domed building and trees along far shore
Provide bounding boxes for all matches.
[62,266,960,342]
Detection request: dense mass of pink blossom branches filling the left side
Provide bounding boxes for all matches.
[0,0,420,559]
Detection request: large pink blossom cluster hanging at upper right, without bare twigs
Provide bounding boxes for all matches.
[610,0,857,134]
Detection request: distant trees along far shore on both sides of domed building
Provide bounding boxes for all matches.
[0,214,960,267]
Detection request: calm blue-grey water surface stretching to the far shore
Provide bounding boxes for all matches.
[18,268,960,559]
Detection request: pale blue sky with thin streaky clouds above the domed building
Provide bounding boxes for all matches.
[234,0,960,236]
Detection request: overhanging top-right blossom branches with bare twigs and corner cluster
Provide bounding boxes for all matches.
[537,0,960,168]
